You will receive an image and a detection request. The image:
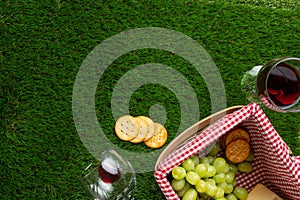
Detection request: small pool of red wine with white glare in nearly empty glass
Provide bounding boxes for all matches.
[98,158,121,184]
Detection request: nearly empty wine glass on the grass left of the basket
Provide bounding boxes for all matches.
[82,150,136,200]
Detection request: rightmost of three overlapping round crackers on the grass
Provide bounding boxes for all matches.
[144,123,168,148]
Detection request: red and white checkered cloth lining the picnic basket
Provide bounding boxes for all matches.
[154,103,300,200]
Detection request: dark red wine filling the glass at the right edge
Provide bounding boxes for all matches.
[267,62,300,107]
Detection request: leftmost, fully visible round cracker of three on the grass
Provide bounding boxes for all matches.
[115,115,140,141]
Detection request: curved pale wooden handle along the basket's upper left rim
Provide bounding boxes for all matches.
[155,106,243,170]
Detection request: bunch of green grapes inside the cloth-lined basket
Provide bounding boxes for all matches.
[171,143,252,200]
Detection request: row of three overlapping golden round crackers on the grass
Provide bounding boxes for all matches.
[115,115,168,148]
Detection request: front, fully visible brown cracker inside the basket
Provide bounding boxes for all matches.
[225,139,250,163]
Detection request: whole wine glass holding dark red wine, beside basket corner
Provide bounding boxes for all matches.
[241,57,300,113]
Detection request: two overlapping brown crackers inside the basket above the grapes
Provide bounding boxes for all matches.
[220,127,251,163]
